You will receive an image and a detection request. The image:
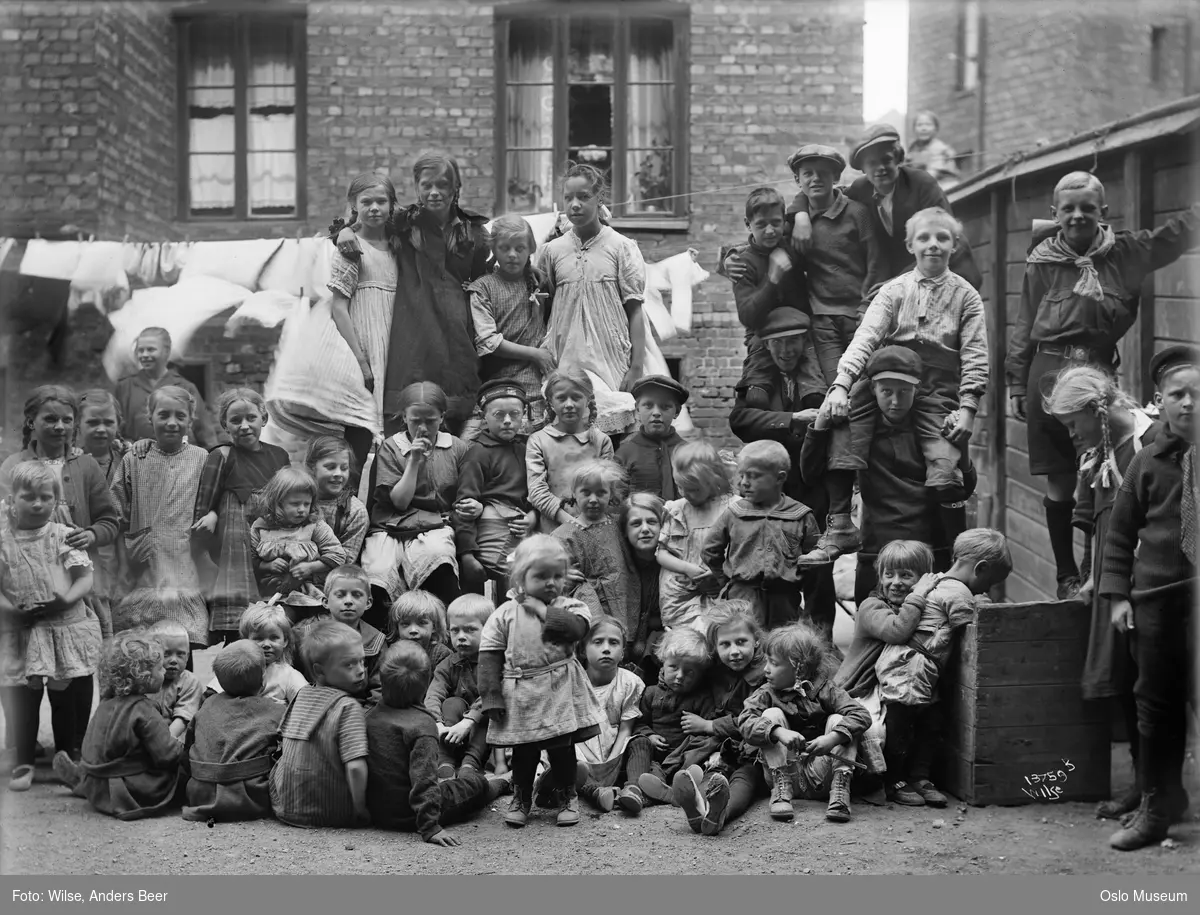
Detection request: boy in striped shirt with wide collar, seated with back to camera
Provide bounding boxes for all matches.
[270,620,371,827]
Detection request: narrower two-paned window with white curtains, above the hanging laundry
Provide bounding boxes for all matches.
[178,12,305,220]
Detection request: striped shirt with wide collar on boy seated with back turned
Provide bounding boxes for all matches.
[271,686,367,826]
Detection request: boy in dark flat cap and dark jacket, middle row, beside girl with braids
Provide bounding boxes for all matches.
[617,375,688,502]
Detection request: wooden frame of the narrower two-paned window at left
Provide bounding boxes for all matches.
[172,4,308,223]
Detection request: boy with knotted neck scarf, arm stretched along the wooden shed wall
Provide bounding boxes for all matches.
[1006,172,1200,599]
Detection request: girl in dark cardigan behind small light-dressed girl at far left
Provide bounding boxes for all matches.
[0,384,119,590]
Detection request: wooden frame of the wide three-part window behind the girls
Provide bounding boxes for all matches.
[493,0,691,229]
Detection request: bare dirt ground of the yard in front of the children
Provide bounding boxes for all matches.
[0,633,1200,874]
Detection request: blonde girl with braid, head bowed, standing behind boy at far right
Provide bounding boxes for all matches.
[1045,365,1162,819]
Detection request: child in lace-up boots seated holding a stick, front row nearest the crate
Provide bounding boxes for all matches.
[738,622,871,823]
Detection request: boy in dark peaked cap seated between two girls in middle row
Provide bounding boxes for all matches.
[455,378,536,588]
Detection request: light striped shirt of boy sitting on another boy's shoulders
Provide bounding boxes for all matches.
[834,270,988,411]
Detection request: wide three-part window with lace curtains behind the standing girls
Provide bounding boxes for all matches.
[496,2,689,221]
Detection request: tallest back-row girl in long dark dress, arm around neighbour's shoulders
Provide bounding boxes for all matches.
[331,155,488,435]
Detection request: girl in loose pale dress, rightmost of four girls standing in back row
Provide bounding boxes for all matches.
[538,165,646,417]
